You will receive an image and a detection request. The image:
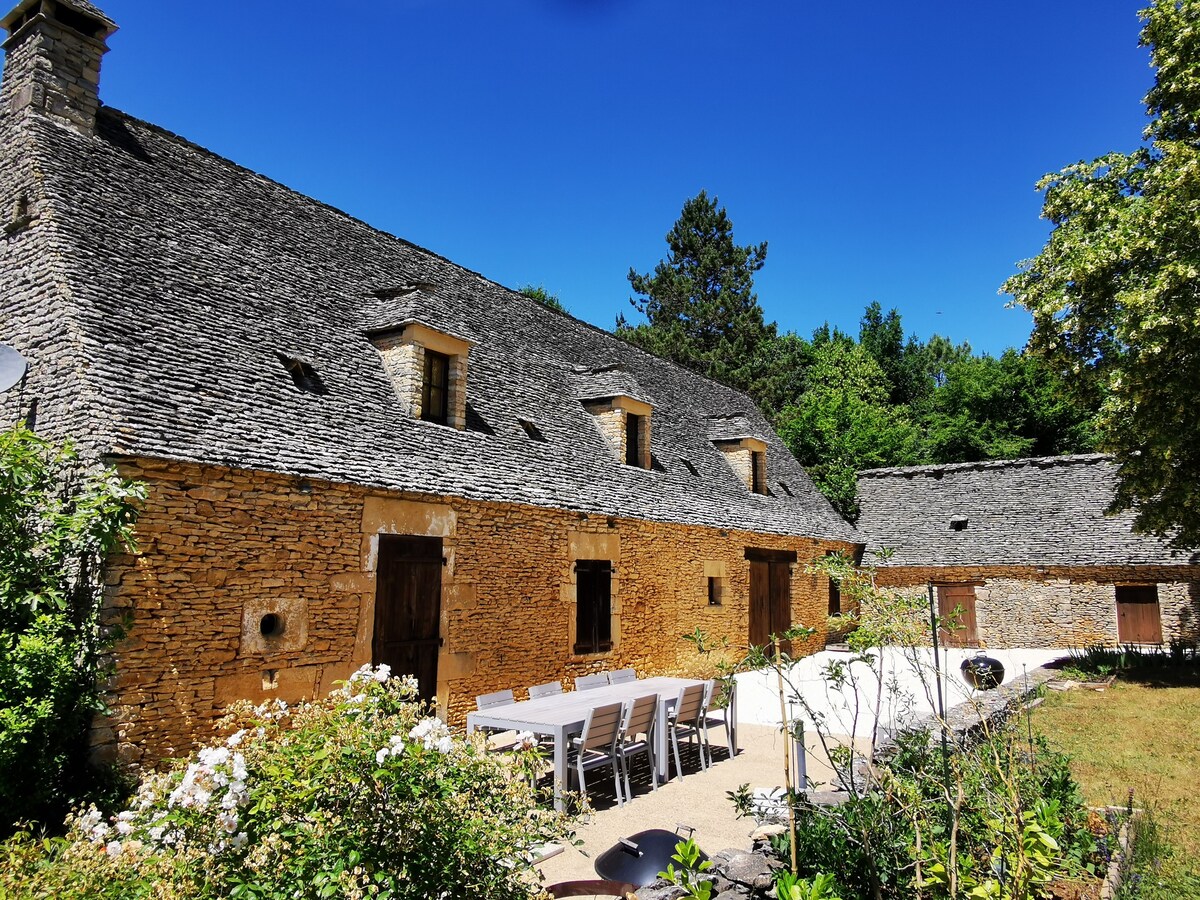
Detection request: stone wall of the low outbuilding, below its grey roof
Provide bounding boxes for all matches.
[878,565,1200,647]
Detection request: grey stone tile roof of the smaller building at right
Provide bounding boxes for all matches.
[858,455,1189,566]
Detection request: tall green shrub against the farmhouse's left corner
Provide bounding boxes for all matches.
[0,426,143,835]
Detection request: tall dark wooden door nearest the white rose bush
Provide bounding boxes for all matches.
[371,534,442,700]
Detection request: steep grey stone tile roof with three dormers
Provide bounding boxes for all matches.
[18,108,854,540]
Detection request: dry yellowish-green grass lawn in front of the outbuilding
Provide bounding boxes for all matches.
[1033,666,1200,900]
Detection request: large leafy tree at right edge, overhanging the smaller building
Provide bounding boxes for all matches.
[1003,0,1200,547]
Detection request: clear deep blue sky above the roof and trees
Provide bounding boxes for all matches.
[88,0,1152,353]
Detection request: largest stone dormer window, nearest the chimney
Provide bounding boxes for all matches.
[370,320,472,431]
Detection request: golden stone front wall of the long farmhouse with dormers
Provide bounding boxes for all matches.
[105,460,854,761]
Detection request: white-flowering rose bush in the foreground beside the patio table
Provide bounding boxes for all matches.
[0,666,569,900]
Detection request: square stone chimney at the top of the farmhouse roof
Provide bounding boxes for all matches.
[0,0,116,134]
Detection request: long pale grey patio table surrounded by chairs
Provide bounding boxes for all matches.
[467,677,703,809]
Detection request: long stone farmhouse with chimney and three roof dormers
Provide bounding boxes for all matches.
[0,0,858,761]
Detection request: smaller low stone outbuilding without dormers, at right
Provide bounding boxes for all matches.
[858,455,1200,647]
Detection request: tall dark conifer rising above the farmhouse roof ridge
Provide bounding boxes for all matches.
[617,191,775,390]
